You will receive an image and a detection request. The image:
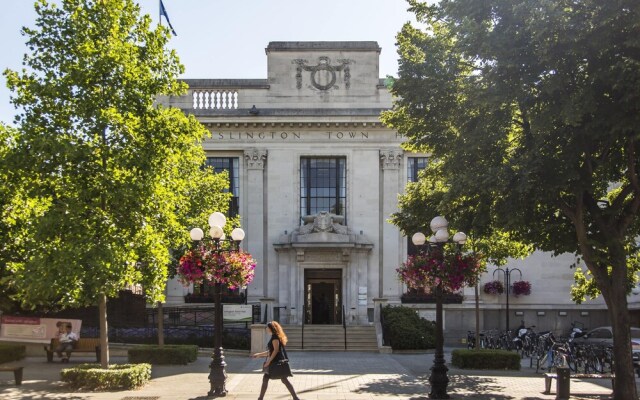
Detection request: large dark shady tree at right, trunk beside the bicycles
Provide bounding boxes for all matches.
[385,0,640,399]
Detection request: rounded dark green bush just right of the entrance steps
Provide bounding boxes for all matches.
[382,305,435,350]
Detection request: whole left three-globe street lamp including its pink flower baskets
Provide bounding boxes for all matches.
[180,212,255,397]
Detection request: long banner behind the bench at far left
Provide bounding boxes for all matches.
[0,315,82,343]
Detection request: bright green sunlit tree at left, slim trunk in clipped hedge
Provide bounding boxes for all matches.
[2,0,228,366]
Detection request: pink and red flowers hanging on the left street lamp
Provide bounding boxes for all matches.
[178,243,256,289]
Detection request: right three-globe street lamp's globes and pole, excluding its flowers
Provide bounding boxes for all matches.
[411,216,467,399]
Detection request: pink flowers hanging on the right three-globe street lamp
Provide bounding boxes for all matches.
[396,250,480,292]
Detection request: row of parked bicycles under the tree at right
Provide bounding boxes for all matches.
[467,322,640,376]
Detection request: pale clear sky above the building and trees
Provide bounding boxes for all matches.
[0,0,415,123]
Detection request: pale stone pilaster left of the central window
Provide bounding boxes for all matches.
[243,149,269,299]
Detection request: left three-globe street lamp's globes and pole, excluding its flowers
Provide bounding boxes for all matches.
[189,212,244,397]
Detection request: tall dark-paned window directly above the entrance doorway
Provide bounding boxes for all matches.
[300,157,347,220]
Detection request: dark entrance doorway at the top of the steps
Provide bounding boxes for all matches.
[304,269,342,325]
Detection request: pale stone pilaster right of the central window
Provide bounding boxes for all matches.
[379,149,404,300]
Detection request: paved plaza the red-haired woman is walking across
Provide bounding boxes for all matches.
[0,351,632,400]
